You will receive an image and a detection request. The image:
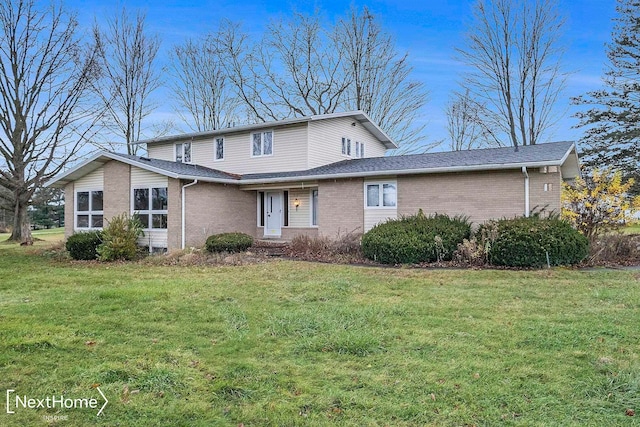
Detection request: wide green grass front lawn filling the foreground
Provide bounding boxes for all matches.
[0,245,640,426]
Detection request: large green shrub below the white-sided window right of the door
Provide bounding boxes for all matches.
[362,210,471,264]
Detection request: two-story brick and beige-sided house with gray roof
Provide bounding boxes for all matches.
[48,111,579,252]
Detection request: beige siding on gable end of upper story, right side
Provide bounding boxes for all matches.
[309,117,386,168]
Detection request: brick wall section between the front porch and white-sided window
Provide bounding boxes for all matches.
[318,178,364,237]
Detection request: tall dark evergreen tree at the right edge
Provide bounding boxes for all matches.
[574,0,640,194]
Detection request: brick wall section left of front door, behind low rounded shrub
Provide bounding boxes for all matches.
[182,183,256,246]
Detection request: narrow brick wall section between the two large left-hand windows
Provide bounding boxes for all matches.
[103,160,131,221]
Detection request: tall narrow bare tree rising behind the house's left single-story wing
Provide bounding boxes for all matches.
[94,8,160,154]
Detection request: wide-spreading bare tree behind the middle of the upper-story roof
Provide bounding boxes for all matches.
[216,13,348,121]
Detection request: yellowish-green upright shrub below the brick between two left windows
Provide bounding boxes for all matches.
[98,213,144,261]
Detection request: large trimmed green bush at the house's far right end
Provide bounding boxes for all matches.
[480,217,589,267]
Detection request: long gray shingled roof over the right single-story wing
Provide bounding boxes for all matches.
[242,141,573,181]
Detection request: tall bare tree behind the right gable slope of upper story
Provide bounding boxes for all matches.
[334,7,427,151]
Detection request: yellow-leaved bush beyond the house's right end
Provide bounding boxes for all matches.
[562,169,640,241]
